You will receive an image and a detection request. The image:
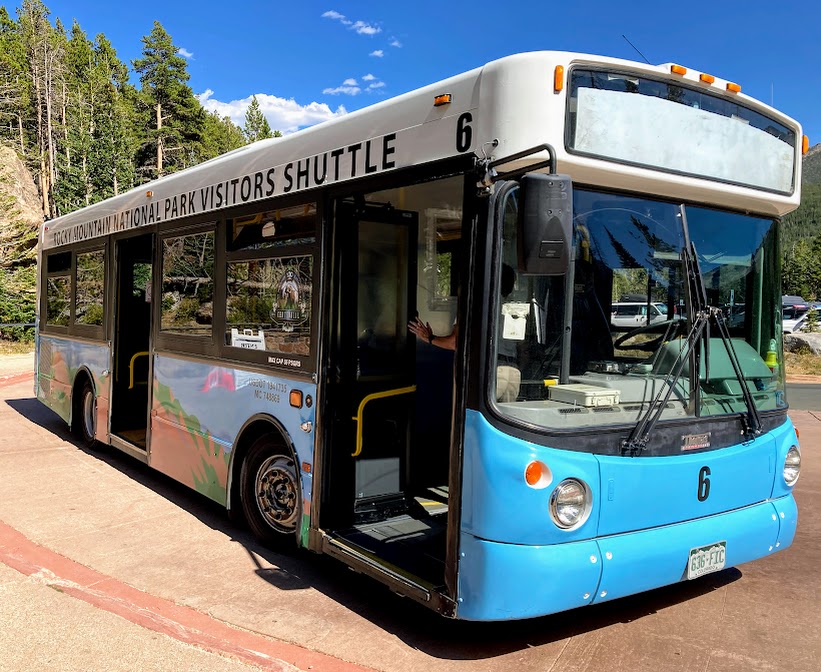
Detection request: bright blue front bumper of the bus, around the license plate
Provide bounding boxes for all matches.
[456,495,798,621]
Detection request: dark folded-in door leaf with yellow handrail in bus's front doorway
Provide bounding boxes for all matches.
[334,203,417,517]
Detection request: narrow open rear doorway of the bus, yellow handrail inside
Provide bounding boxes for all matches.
[111,234,154,450]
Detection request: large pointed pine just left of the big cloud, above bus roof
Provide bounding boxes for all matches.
[133,21,205,178]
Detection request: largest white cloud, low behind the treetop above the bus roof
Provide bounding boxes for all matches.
[197,89,348,135]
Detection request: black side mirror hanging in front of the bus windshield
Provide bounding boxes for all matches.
[518,173,573,275]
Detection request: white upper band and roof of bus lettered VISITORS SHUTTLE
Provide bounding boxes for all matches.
[42,51,801,248]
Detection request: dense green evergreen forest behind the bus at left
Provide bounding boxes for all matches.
[0,0,280,338]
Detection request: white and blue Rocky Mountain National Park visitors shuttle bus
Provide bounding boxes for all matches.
[36,52,807,621]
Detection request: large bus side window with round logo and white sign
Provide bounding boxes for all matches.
[224,203,317,368]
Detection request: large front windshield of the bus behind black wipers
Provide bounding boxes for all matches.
[490,189,785,430]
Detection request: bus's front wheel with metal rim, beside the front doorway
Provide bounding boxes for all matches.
[240,435,302,547]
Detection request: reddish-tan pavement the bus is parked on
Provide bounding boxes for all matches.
[0,368,821,672]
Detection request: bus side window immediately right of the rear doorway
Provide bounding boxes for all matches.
[160,231,214,337]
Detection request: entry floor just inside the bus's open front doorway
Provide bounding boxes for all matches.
[339,506,447,585]
